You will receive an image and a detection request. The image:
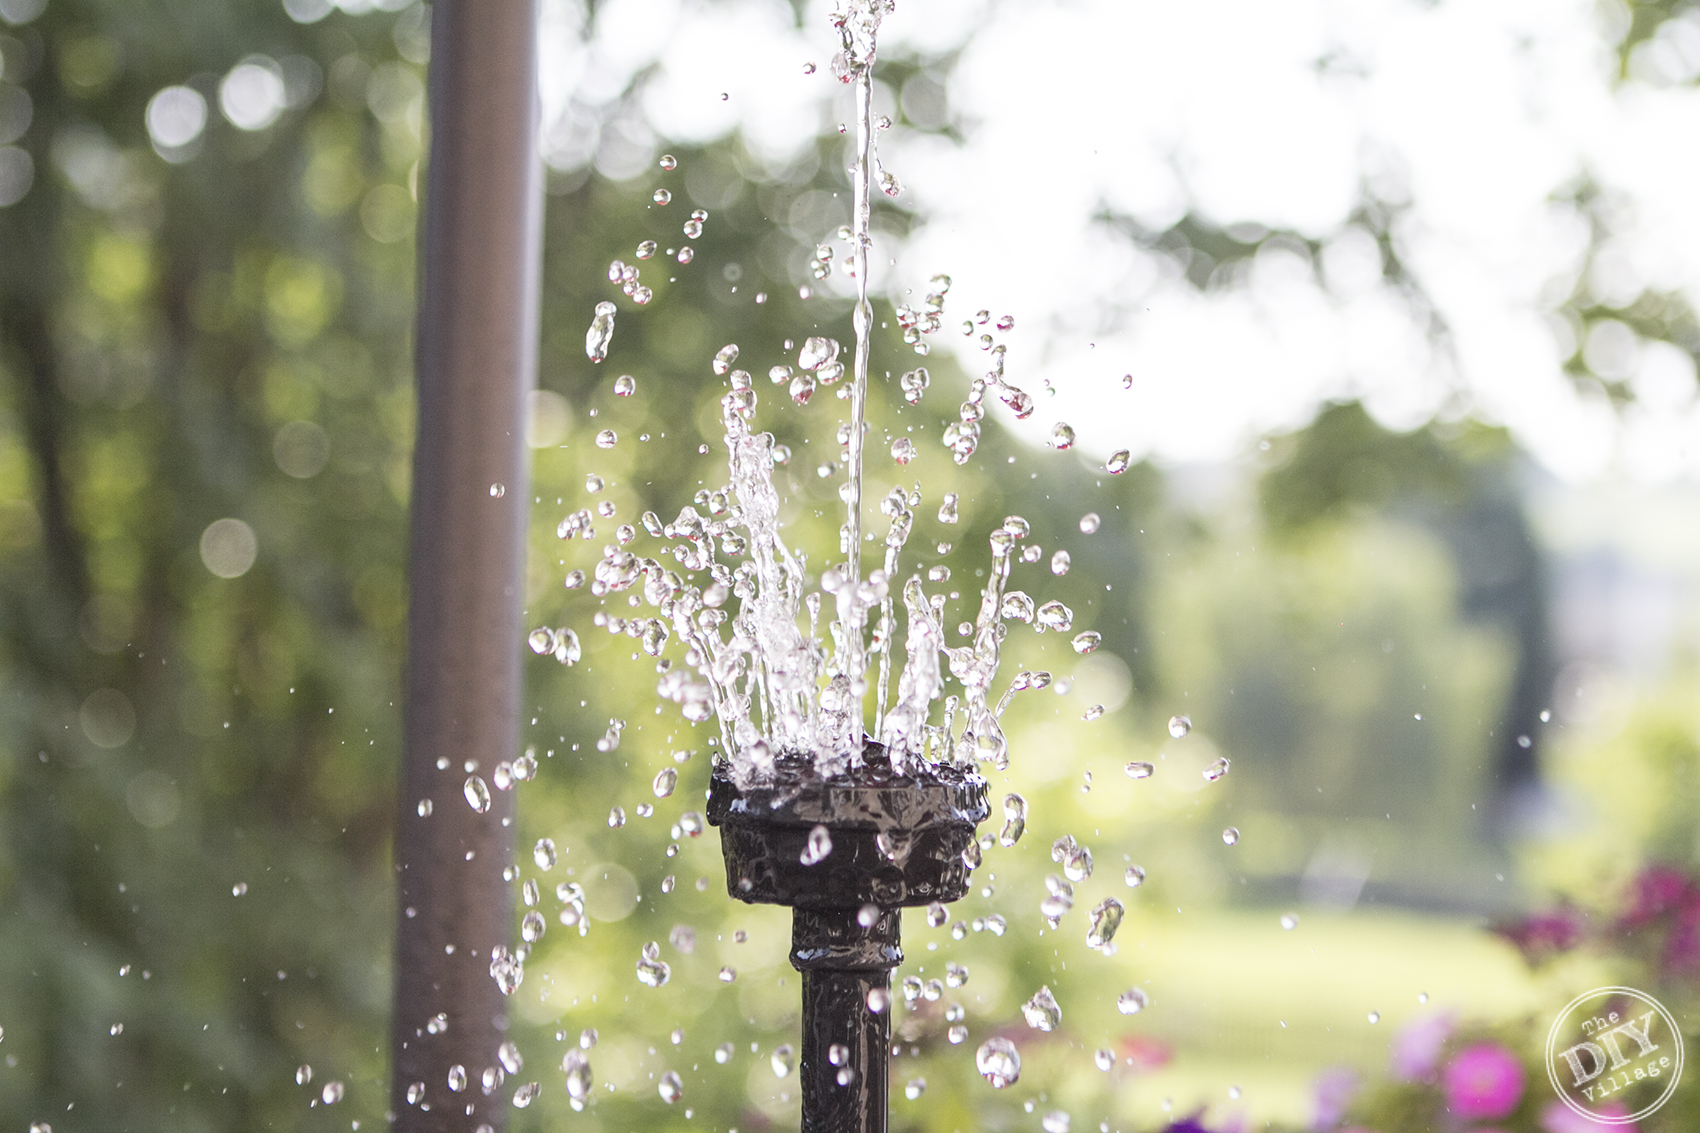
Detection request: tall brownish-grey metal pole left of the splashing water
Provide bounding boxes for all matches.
[391,0,542,1133]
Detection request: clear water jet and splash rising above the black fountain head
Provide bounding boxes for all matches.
[530,0,1067,785]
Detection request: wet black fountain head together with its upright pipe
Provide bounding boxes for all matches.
[709,740,989,1133]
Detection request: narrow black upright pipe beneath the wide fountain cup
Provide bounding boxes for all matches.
[791,908,903,1133]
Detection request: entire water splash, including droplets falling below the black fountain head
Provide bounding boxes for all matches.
[516,0,1169,1109]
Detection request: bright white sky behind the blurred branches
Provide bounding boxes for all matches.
[544,0,1700,481]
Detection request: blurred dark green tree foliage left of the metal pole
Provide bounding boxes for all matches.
[0,0,425,1130]
